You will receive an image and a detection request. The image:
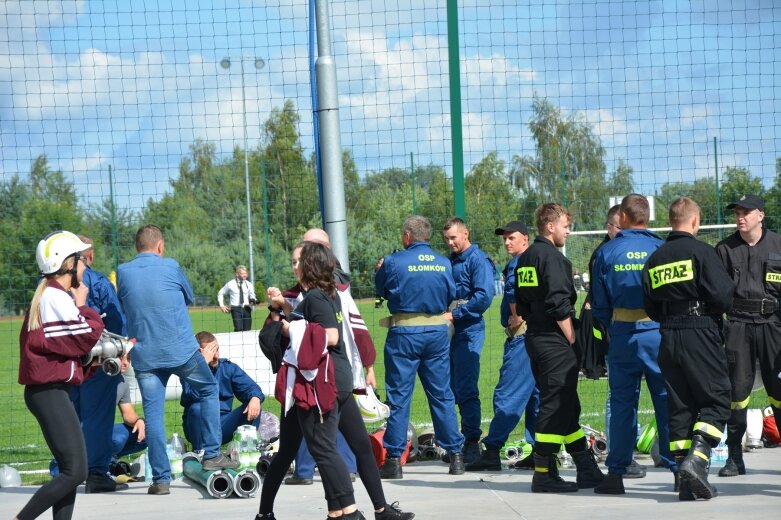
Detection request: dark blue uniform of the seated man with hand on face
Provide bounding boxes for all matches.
[179,359,265,451]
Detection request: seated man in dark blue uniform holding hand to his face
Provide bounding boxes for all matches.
[179,331,265,451]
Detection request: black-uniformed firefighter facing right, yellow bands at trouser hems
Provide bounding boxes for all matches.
[515,203,605,493]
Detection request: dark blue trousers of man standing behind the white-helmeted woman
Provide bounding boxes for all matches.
[71,369,120,474]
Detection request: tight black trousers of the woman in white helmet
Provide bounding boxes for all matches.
[16,383,87,520]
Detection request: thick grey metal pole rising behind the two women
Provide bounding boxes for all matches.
[315,0,350,272]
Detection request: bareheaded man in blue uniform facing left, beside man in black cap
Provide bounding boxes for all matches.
[442,217,494,464]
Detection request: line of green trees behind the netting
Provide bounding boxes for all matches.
[0,97,781,315]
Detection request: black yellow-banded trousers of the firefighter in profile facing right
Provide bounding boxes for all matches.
[526,332,588,456]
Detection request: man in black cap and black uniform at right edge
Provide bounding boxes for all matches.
[716,195,781,477]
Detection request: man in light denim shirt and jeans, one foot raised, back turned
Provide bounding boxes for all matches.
[118,225,239,495]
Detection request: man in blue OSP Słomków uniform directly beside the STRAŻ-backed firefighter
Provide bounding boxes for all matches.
[591,194,677,495]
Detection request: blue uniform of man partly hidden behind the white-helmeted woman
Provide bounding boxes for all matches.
[71,267,127,474]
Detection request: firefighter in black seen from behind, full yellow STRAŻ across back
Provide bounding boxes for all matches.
[643,197,735,500]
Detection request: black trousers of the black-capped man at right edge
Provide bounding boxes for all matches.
[725,320,781,444]
